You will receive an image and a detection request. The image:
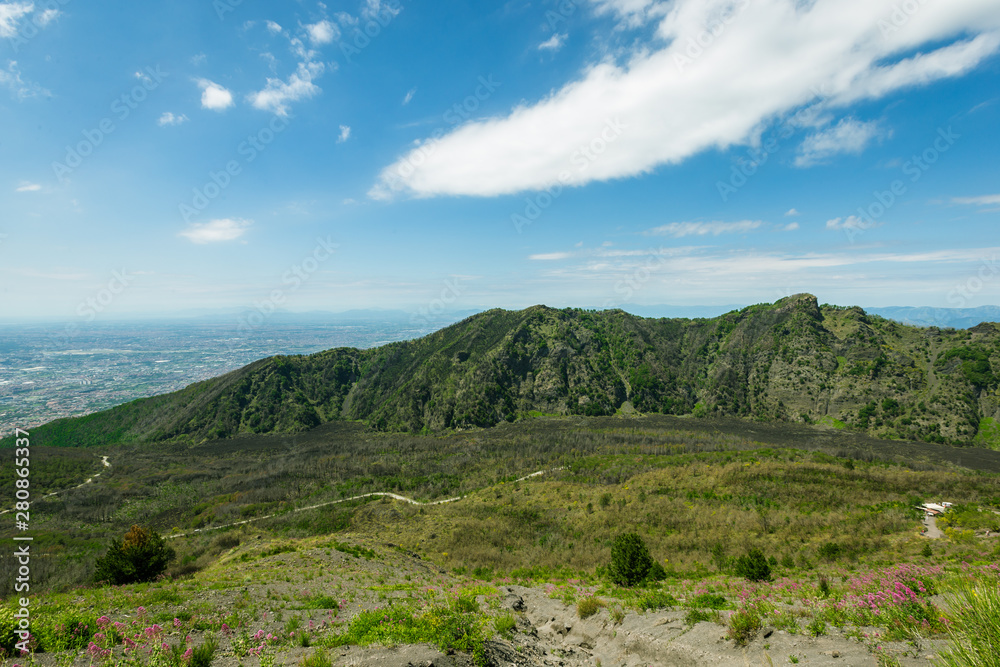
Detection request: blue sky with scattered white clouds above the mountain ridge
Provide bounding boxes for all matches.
[0,0,1000,320]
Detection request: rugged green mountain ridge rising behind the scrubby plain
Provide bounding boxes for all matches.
[7,294,1000,448]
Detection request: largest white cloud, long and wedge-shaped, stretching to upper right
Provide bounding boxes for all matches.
[370,0,1000,198]
